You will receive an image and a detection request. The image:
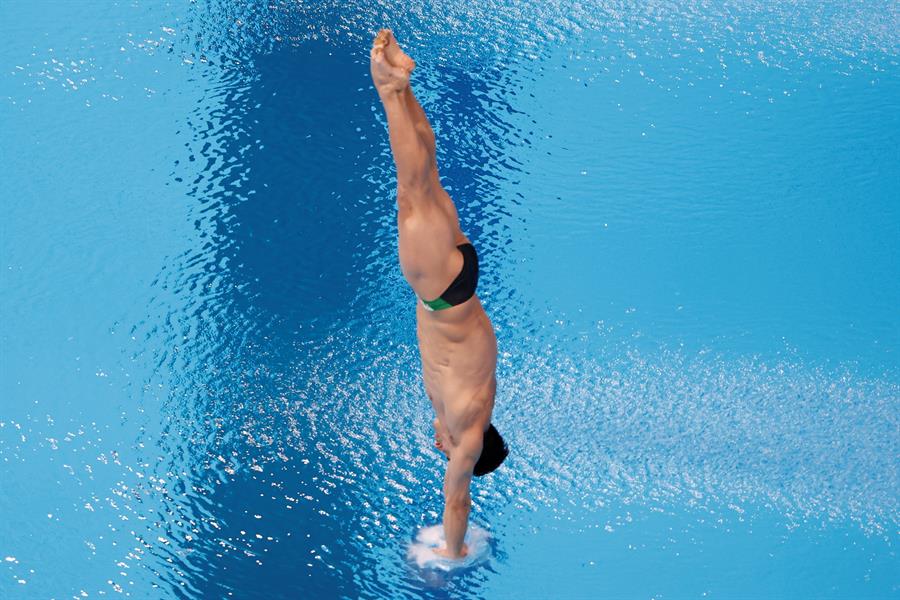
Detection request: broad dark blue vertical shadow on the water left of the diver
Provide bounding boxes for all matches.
[160,38,379,598]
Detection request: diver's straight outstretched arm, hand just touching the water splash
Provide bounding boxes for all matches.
[444,427,483,558]
